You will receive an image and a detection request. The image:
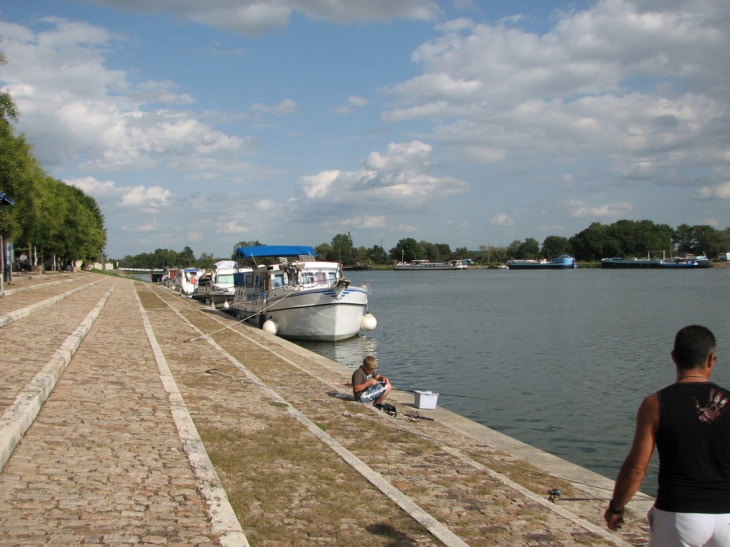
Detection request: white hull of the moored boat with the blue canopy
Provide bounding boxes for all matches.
[231,287,367,342]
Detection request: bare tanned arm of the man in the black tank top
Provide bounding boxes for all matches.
[603,393,661,530]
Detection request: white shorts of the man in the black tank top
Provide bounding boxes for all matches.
[646,507,730,547]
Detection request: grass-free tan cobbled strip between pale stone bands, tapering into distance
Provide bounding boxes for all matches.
[0,281,218,547]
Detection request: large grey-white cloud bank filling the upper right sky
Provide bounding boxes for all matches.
[383,0,730,193]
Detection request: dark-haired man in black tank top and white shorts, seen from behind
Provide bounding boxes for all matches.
[604,325,730,547]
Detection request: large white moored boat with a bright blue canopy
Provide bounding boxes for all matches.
[230,246,377,341]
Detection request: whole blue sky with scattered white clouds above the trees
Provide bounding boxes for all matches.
[0,0,730,258]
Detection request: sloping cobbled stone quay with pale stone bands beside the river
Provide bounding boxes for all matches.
[0,274,650,546]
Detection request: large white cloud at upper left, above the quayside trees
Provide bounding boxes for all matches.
[3,18,256,173]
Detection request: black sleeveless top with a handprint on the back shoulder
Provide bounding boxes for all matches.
[655,382,730,514]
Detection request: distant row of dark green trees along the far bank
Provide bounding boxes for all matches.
[120,220,730,269]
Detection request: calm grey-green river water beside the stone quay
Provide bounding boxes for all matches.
[299,268,730,494]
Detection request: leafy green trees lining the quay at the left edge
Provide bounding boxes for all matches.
[0,41,107,274]
